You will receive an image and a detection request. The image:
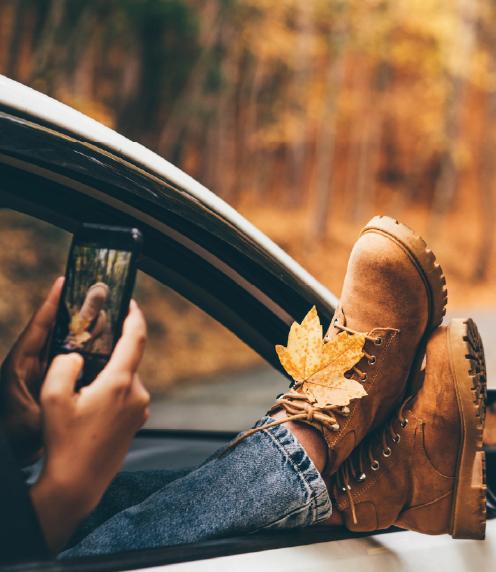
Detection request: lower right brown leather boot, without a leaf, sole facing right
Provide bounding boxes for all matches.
[331,320,486,539]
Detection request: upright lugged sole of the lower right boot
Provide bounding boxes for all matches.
[448,319,487,540]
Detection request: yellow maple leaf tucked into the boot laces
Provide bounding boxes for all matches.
[276,306,367,407]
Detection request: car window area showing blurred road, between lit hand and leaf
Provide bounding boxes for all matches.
[136,272,288,431]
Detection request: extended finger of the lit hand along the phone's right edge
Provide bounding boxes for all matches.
[104,300,146,385]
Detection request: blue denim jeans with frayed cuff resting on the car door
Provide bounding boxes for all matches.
[60,417,331,558]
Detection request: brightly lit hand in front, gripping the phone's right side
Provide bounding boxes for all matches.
[31,302,150,552]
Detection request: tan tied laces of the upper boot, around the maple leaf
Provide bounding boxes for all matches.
[228,319,383,450]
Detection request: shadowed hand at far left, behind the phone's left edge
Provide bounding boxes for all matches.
[0,277,64,466]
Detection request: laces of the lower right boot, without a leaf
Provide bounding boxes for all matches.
[335,398,411,524]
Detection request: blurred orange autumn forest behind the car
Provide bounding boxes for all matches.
[0,0,496,394]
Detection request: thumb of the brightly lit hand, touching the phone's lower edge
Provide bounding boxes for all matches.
[41,353,84,403]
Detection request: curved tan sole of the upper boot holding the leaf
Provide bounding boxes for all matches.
[361,215,448,395]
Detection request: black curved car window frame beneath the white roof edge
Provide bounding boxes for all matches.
[0,111,335,374]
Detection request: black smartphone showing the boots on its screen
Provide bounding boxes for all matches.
[50,224,143,388]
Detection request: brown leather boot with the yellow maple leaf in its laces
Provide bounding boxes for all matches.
[232,216,447,474]
